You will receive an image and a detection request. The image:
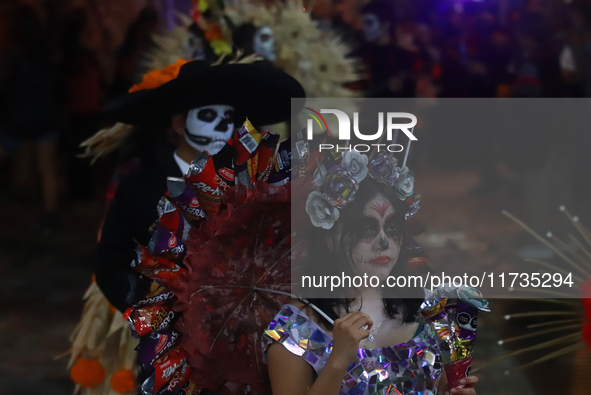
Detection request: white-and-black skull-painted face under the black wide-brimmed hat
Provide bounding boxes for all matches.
[185,104,234,155]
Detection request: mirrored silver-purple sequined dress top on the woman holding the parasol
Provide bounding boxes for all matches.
[263,305,442,395]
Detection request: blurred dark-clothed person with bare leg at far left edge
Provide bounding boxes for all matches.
[0,5,59,233]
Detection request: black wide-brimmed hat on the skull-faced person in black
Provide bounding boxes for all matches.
[103,61,305,126]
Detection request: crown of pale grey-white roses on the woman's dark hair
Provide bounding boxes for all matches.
[306,151,420,229]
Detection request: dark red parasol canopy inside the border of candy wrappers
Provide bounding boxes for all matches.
[175,183,291,394]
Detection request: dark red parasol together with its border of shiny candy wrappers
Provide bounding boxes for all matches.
[119,120,291,395]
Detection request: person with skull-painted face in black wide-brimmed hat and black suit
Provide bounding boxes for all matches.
[96,61,305,311]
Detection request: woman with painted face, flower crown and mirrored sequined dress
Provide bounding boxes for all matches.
[263,146,486,395]
